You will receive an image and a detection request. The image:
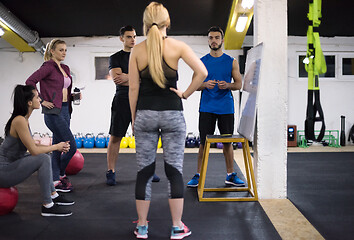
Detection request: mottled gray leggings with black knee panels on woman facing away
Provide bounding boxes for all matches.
[134,110,186,200]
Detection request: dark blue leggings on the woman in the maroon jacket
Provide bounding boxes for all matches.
[44,103,76,181]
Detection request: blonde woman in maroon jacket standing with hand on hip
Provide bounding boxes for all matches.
[26,39,76,192]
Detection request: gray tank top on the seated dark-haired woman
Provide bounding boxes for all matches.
[0,134,27,168]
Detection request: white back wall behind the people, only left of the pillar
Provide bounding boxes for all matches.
[0,36,242,135]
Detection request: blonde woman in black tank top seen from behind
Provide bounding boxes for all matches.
[129,2,207,239]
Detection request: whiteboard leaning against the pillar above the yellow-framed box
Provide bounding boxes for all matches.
[237,43,263,142]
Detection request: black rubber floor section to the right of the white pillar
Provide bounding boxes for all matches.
[288,152,354,240]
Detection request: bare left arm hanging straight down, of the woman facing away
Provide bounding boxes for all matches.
[128,49,140,132]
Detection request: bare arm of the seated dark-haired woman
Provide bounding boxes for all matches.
[10,116,70,156]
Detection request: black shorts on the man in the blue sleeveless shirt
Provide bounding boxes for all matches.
[199,112,235,145]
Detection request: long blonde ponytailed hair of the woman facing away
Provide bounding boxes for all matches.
[143,2,170,88]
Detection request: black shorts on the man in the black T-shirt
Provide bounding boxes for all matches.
[109,96,132,137]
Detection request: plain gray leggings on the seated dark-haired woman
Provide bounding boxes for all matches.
[0,154,55,203]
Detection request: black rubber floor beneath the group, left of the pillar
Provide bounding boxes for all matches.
[0,154,281,240]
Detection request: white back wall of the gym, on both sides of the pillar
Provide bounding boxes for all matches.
[0,36,354,144]
